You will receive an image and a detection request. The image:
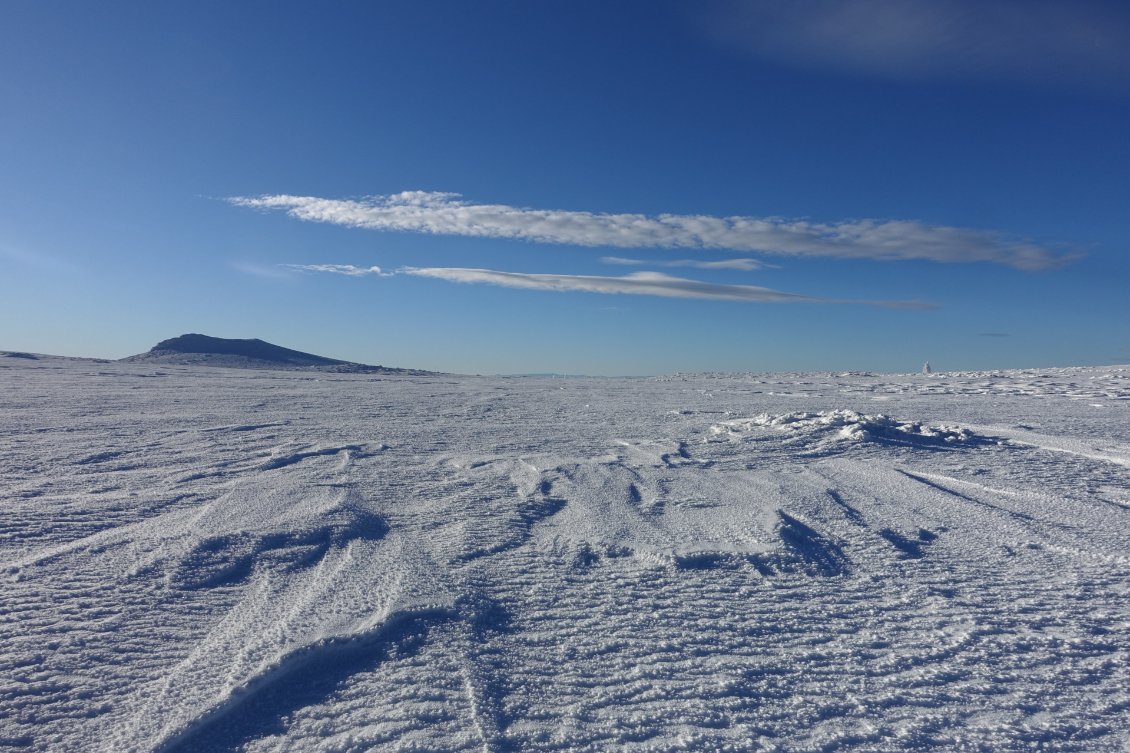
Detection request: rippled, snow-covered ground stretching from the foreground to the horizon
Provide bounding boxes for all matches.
[0,357,1130,752]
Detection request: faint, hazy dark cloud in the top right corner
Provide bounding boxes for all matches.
[707,0,1130,87]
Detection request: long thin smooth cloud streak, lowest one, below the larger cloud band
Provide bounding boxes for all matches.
[398,267,937,309]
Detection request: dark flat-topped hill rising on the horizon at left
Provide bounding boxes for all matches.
[122,334,436,375]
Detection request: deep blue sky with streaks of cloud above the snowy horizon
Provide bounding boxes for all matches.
[0,0,1130,374]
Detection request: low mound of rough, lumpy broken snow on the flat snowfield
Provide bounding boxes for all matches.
[710,409,984,445]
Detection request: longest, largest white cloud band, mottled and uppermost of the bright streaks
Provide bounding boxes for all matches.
[228,191,1070,270]
